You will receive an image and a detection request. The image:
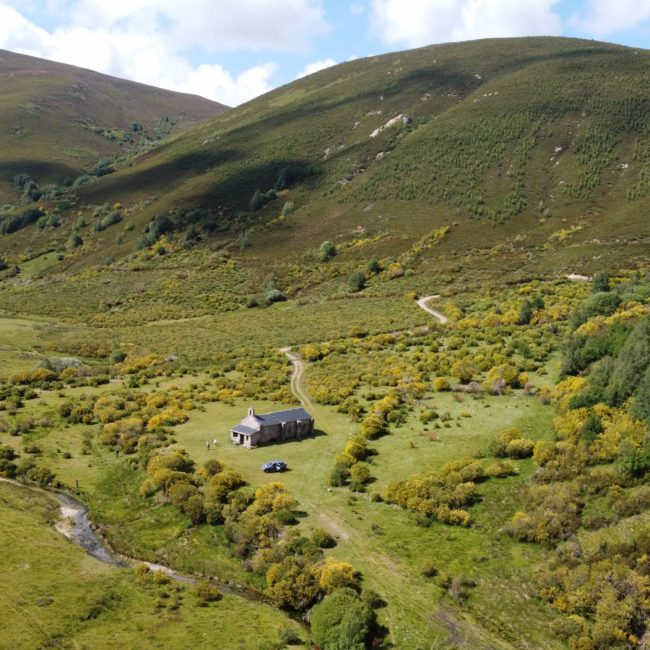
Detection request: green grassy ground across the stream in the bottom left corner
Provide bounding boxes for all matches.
[0,476,298,650]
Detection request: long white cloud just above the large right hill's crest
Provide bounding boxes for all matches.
[372,0,562,47]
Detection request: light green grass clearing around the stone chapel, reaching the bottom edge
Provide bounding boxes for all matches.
[165,382,560,648]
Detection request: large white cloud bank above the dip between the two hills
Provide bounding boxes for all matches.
[0,0,316,106]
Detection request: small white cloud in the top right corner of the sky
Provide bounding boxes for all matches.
[570,0,650,37]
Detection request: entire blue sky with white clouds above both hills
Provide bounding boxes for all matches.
[0,0,650,106]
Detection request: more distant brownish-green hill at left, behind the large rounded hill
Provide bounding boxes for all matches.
[0,50,225,203]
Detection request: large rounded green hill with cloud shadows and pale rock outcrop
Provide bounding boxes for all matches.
[0,37,650,320]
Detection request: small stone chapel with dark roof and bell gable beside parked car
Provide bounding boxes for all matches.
[230,408,314,449]
